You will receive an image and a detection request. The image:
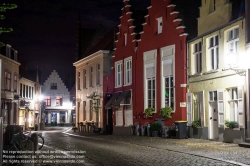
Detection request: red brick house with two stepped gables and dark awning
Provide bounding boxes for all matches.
[105,0,198,134]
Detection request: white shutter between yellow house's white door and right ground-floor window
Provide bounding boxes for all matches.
[217,89,224,127]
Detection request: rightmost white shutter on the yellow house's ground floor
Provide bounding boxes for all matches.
[238,86,245,128]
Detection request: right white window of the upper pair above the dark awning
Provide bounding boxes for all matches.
[124,56,132,85]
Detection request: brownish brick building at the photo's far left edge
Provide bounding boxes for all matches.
[0,44,20,125]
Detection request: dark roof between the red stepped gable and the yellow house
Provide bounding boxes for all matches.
[171,0,201,40]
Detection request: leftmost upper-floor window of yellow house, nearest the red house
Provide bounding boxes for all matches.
[193,42,202,74]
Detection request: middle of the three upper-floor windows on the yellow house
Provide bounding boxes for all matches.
[208,35,219,70]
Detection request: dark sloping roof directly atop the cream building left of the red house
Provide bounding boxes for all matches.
[86,27,118,56]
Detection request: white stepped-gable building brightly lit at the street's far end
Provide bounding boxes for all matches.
[42,70,74,126]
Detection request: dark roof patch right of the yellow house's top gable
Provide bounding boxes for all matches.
[230,0,245,21]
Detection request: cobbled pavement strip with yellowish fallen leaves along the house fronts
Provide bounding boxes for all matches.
[65,128,250,165]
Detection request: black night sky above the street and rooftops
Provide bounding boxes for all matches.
[0,0,149,89]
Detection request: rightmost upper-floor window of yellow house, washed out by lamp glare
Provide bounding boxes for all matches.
[225,27,240,68]
